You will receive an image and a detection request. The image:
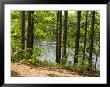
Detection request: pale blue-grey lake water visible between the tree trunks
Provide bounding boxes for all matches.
[37,42,100,69]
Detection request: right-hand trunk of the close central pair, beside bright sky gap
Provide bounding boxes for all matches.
[62,11,68,58]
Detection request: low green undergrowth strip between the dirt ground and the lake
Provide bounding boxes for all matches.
[11,48,100,76]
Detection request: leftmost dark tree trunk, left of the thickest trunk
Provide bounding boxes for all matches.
[21,11,25,50]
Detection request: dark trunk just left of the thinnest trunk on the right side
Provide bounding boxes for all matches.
[74,11,81,64]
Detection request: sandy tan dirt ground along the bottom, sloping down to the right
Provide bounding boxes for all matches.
[11,62,99,77]
